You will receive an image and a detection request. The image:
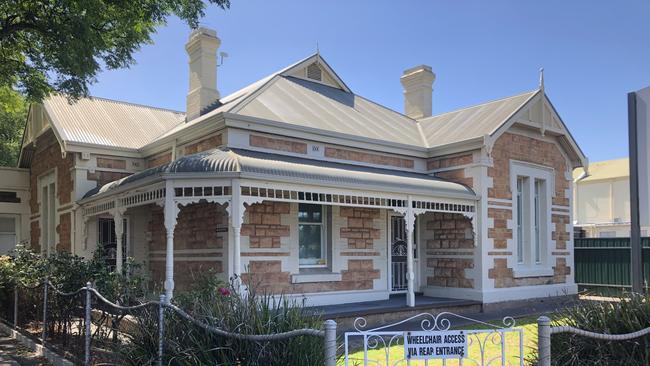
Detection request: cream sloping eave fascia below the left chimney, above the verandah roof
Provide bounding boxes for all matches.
[139,113,225,157]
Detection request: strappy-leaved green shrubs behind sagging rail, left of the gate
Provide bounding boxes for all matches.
[121,275,324,366]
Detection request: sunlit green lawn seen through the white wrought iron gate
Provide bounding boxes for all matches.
[338,316,552,366]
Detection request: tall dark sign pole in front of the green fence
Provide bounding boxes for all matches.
[627,92,643,293]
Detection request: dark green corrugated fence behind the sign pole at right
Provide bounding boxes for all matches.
[574,238,650,287]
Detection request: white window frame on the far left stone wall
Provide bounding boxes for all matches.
[36,170,59,256]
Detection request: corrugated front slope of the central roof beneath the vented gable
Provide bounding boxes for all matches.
[237,76,423,146]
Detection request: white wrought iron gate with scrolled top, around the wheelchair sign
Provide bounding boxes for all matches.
[344,312,524,366]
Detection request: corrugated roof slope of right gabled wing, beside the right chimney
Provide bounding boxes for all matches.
[418,90,539,147]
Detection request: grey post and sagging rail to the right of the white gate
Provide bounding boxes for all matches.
[537,316,650,366]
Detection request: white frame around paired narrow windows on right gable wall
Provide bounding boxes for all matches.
[510,160,555,277]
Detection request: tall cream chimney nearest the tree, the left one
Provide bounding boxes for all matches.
[185,27,221,121]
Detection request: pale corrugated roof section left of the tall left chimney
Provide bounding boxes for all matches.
[43,95,185,149]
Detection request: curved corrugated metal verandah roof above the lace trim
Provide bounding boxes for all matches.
[84,149,476,199]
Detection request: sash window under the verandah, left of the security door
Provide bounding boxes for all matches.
[298,203,327,268]
